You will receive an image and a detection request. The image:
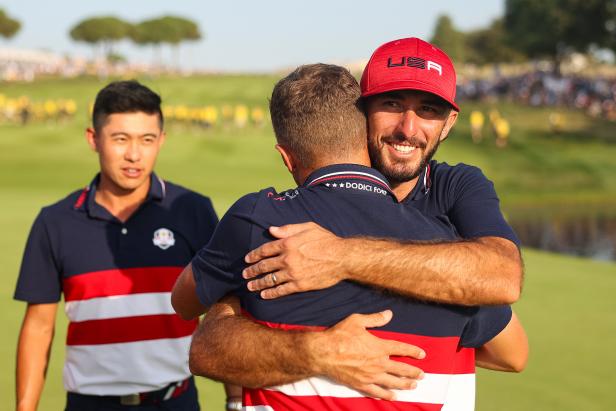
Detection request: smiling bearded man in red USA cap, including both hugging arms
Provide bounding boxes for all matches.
[183,38,522,408]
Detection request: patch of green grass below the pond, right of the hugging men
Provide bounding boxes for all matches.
[477,250,616,411]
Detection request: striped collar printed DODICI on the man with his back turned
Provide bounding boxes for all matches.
[303,164,396,200]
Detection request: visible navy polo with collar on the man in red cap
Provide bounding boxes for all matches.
[410,160,520,248]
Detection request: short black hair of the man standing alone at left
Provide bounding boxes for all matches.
[92,80,164,131]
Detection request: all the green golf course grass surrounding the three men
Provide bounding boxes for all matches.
[0,76,616,411]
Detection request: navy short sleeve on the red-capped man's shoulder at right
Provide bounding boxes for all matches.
[447,165,520,247]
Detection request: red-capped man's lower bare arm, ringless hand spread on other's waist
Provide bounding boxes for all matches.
[189,297,425,399]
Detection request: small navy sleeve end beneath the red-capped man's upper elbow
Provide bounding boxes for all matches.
[460,305,512,348]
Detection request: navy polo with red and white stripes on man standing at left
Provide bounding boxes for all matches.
[15,174,218,395]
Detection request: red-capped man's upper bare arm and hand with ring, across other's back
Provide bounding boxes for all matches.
[244,222,522,305]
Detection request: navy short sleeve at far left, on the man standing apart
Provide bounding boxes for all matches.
[14,212,62,304]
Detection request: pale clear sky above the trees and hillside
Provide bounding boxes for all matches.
[0,0,504,72]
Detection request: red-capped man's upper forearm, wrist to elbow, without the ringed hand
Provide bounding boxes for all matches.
[341,237,522,305]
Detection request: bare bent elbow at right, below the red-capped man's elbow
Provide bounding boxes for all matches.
[475,313,528,372]
